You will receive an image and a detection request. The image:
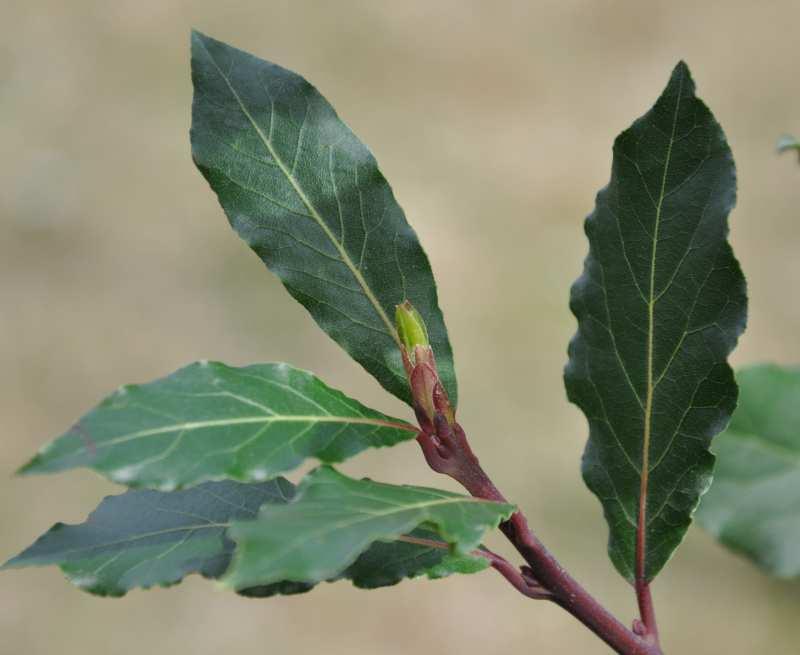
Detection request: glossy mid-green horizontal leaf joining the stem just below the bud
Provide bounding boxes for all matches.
[21,362,416,490]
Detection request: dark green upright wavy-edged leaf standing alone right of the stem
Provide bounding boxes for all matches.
[565,62,747,580]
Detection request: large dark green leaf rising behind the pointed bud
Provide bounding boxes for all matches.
[191,32,457,405]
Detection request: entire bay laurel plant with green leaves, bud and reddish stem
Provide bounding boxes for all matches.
[5,33,800,655]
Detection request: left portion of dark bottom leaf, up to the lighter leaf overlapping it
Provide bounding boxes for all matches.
[3,478,294,596]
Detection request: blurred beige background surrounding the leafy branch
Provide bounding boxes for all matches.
[0,0,800,655]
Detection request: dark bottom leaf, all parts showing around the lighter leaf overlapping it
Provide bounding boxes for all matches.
[3,478,488,598]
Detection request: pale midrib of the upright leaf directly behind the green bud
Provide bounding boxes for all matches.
[195,37,401,347]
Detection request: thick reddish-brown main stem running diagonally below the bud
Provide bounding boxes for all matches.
[417,414,662,655]
